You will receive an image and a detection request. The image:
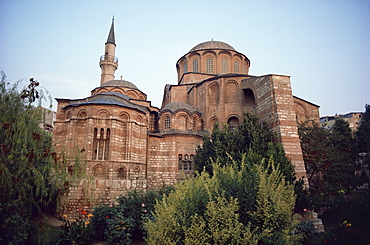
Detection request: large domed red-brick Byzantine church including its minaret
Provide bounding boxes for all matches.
[54,18,319,213]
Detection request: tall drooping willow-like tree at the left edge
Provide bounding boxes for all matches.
[0,73,88,244]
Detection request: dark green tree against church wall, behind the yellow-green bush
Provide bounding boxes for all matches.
[194,113,294,181]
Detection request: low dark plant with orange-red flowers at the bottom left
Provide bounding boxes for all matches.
[58,210,94,245]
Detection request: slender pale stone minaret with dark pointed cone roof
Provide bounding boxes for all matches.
[99,17,118,86]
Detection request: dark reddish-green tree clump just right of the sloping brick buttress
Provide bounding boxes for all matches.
[298,119,360,208]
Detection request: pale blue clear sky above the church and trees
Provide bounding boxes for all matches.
[0,0,370,116]
